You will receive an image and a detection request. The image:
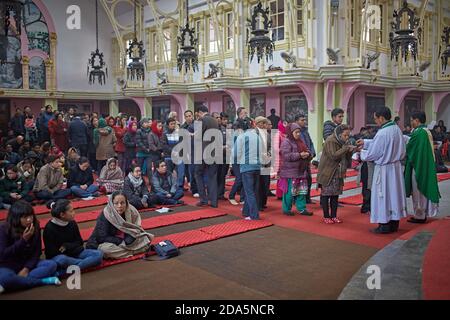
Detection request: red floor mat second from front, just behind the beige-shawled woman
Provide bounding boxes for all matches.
[42,209,226,249]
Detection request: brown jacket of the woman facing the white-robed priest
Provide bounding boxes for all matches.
[317,133,352,186]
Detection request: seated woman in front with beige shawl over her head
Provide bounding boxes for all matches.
[86,191,154,259]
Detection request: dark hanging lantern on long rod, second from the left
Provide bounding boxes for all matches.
[126,0,145,81]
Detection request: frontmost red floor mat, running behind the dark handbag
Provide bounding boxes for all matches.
[86,220,272,272]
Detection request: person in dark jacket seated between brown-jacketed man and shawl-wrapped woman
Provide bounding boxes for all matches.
[67,157,98,200]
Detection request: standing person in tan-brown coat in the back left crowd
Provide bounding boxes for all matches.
[94,118,117,171]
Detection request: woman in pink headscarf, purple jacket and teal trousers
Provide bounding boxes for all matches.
[279,123,312,216]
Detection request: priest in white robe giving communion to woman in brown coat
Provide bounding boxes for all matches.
[358,107,406,234]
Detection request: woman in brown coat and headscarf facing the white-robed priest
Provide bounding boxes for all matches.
[317,124,357,224]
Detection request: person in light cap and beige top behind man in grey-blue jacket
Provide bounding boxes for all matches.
[255,116,271,211]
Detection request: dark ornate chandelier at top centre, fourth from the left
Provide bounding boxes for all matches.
[248,1,275,63]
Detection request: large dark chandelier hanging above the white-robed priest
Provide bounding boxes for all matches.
[389,0,422,62]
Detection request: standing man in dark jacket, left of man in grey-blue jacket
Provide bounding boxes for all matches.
[194,105,222,208]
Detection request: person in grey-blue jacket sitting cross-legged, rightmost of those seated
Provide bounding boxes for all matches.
[152,161,184,205]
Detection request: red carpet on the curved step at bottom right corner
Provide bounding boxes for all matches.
[422,220,450,300]
